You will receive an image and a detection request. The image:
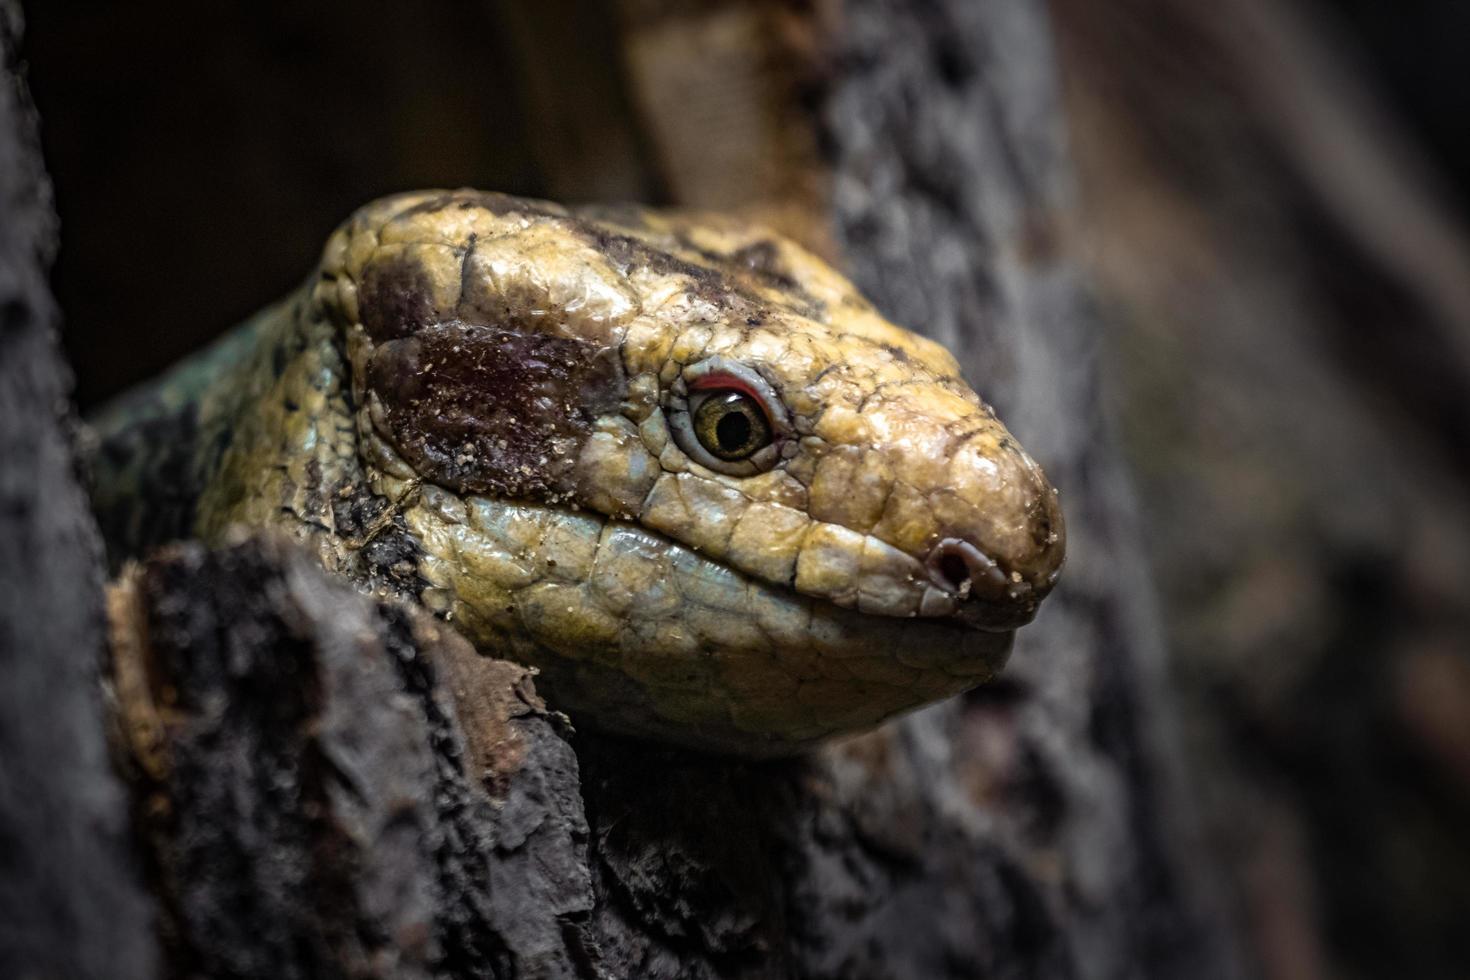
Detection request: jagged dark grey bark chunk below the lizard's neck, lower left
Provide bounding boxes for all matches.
[112,541,592,977]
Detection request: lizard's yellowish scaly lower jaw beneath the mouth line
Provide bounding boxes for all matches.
[406,498,1013,755]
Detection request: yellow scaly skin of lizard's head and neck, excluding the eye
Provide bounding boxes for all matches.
[97,191,1063,755]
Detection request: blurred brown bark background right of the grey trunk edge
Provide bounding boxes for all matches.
[1053,0,1470,980]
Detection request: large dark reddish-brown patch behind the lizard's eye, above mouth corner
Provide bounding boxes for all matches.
[368,322,625,498]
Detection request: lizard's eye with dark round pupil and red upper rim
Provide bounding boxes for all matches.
[666,357,789,476]
